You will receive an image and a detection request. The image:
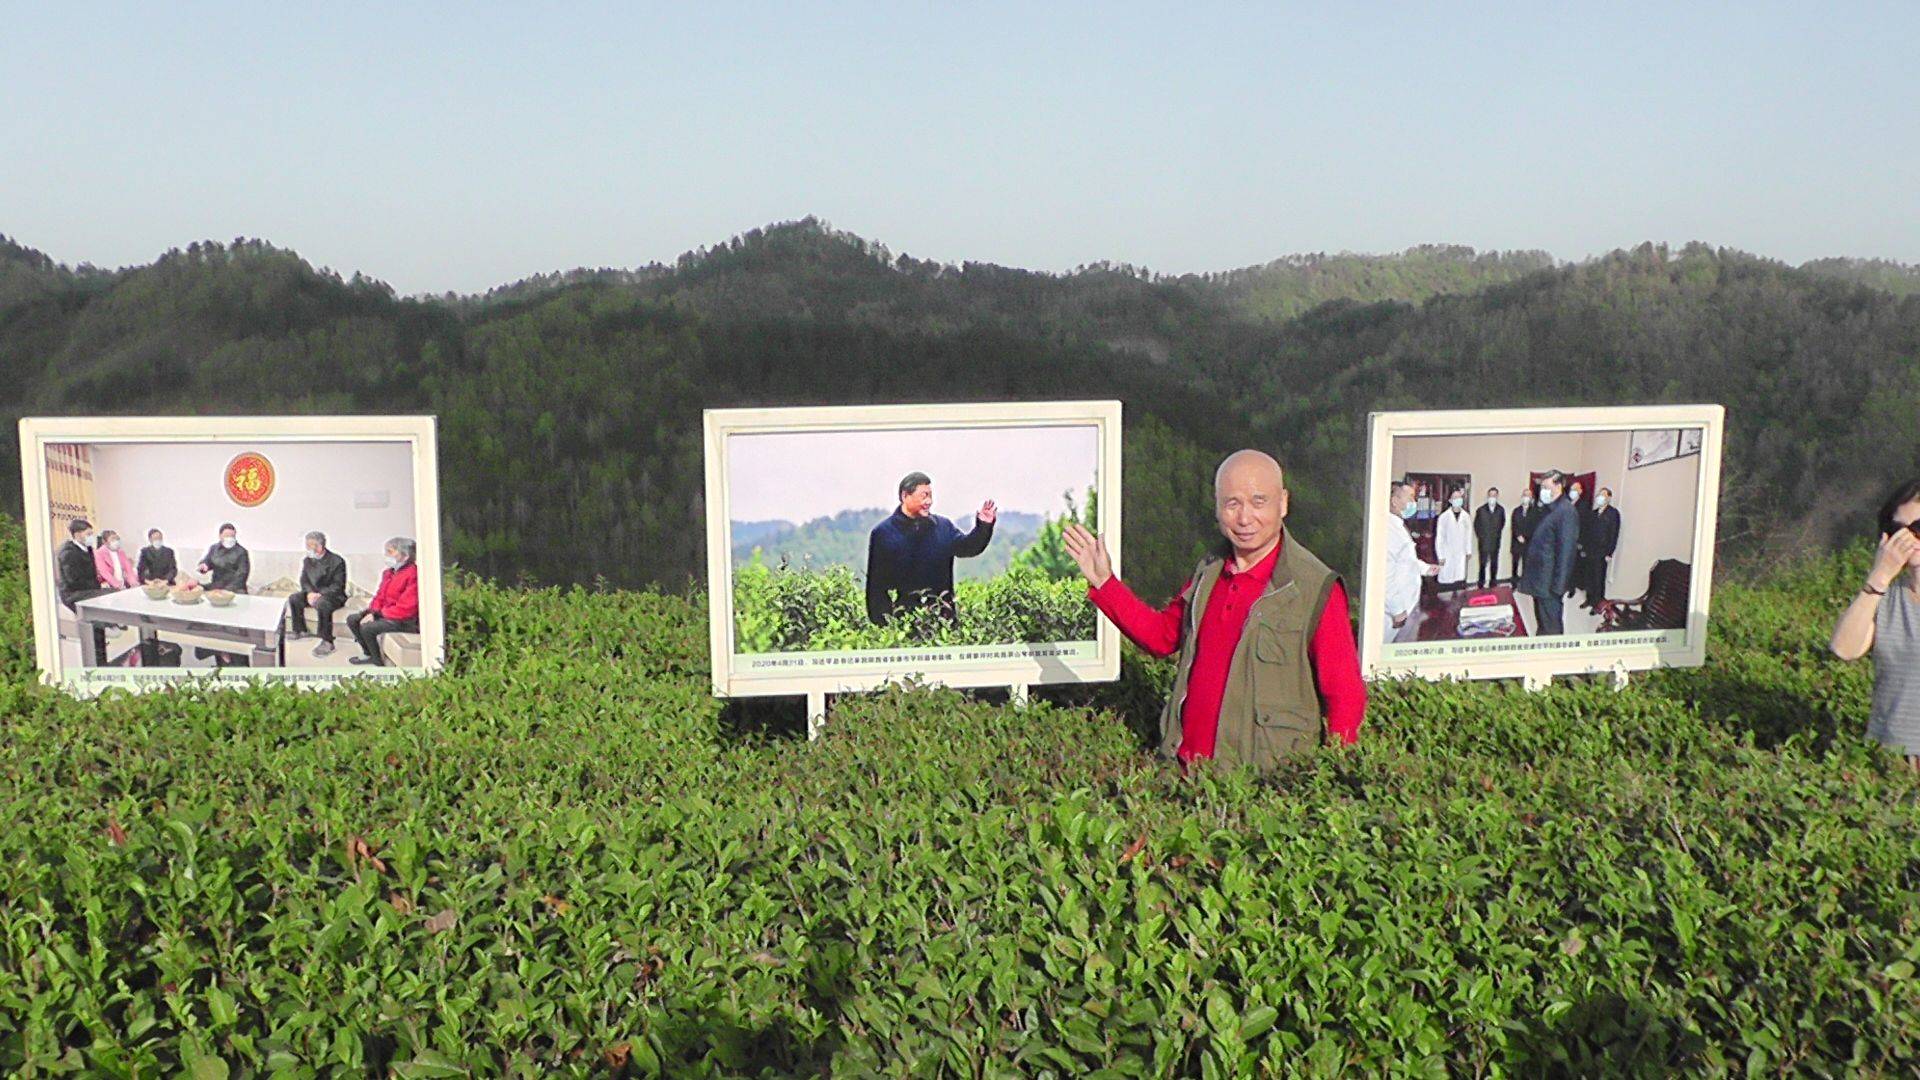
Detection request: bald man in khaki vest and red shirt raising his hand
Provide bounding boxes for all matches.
[1066,450,1367,769]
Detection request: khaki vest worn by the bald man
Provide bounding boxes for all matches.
[1160,534,1340,771]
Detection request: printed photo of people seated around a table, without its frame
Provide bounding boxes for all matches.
[29,421,440,675]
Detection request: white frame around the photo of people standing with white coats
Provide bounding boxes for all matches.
[1359,405,1726,688]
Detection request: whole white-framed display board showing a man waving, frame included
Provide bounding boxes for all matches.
[707,402,1119,696]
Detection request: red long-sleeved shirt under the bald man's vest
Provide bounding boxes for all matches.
[1087,534,1367,763]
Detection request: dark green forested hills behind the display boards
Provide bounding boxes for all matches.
[0,219,1920,590]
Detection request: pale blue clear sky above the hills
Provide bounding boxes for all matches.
[0,2,1920,292]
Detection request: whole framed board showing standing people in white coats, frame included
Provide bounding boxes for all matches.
[1361,405,1724,678]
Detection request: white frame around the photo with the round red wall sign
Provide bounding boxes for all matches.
[19,407,445,698]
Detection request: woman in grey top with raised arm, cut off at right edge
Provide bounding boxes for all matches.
[1832,480,1920,771]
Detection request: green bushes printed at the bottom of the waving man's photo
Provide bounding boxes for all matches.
[733,559,1096,653]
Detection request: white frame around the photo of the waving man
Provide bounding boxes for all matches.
[705,402,1123,698]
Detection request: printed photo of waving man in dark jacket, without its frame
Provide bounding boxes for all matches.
[726,423,1104,655]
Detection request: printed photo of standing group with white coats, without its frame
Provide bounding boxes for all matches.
[1377,429,1701,651]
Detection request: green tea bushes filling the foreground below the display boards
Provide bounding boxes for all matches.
[0,511,1920,1076]
